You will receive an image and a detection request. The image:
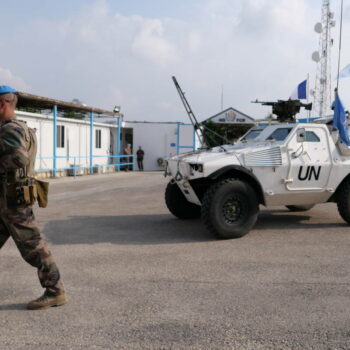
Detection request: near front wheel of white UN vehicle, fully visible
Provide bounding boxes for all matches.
[202,178,259,239]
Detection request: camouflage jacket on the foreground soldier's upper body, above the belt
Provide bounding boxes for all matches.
[0,118,36,180]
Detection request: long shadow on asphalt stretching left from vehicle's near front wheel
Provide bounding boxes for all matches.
[43,215,215,245]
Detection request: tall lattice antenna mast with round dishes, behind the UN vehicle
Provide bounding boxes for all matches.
[312,0,335,118]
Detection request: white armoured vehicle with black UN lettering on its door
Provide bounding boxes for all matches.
[165,123,350,238]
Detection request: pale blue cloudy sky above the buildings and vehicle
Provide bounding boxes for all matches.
[0,0,350,121]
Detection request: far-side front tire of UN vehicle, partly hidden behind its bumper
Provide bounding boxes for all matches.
[165,182,201,219]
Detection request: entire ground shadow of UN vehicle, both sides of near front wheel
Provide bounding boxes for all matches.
[44,210,345,245]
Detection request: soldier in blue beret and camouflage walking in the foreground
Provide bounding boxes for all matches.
[0,86,67,310]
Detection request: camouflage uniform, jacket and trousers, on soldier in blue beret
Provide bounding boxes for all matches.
[0,119,64,295]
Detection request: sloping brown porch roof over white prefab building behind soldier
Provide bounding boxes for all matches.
[17,92,116,116]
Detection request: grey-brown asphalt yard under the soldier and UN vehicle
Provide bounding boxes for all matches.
[0,173,350,350]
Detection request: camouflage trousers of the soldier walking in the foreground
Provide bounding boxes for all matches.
[0,206,64,294]
